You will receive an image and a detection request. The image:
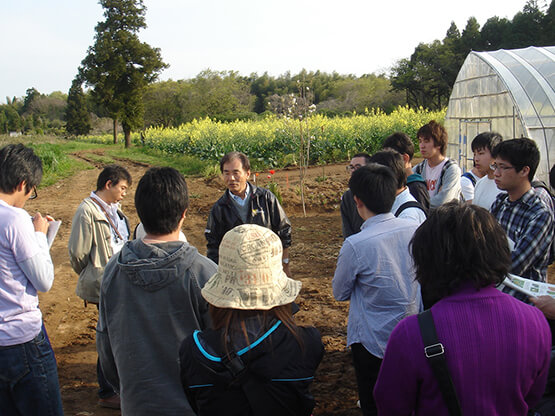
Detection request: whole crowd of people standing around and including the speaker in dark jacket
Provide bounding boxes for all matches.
[0,116,555,416]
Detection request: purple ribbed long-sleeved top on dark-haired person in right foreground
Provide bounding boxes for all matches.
[374,287,551,416]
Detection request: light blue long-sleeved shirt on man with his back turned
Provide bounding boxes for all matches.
[332,212,422,358]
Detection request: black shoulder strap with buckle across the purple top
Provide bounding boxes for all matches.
[418,309,462,416]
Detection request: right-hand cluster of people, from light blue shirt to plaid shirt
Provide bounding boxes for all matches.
[333,121,555,415]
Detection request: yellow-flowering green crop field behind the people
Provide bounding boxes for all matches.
[76,107,445,168]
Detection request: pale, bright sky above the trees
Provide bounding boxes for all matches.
[0,0,532,103]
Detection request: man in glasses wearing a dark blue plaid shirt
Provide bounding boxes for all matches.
[490,138,553,282]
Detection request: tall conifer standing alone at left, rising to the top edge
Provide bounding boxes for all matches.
[79,0,167,147]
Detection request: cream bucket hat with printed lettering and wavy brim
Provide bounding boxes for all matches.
[202,224,301,310]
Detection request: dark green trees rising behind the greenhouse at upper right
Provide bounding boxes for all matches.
[391,0,555,109]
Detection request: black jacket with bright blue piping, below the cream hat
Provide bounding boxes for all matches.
[179,317,324,416]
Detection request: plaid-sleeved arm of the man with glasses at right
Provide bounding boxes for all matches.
[511,209,553,275]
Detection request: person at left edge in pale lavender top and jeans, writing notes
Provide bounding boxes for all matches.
[0,144,63,415]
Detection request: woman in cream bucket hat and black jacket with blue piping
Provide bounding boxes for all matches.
[179,224,324,416]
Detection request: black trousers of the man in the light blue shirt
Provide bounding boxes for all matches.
[351,343,382,416]
